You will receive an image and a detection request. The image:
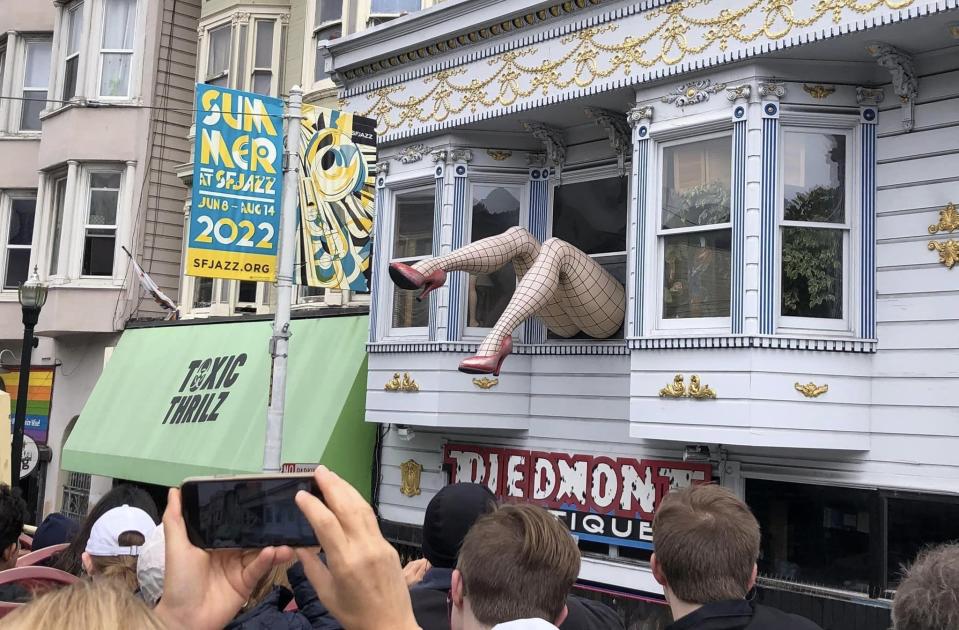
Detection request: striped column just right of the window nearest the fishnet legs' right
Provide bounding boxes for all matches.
[729,101,749,335]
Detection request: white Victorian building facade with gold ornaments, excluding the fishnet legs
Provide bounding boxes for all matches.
[320,0,959,628]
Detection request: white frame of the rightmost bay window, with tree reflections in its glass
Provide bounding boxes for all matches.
[774,112,862,336]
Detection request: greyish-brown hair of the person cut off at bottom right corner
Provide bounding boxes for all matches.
[892,543,959,630]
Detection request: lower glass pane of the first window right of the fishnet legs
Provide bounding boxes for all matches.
[663,230,730,319]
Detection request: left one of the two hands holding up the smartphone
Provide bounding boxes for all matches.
[155,488,293,630]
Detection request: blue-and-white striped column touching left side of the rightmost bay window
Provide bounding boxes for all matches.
[759,100,779,335]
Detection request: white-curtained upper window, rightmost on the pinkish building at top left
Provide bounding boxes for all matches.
[100,0,137,98]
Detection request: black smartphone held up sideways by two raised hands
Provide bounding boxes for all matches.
[181,473,323,549]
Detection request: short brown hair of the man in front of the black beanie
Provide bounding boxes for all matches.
[456,504,580,626]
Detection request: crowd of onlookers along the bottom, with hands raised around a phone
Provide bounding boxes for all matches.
[0,474,959,630]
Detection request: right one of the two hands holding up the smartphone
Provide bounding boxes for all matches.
[296,466,418,630]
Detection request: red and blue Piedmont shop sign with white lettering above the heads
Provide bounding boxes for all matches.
[443,444,712,549]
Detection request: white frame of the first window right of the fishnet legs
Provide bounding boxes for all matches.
[647,129,733,336]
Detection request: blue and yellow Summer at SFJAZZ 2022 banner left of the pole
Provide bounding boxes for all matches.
[186,84,283,282]
